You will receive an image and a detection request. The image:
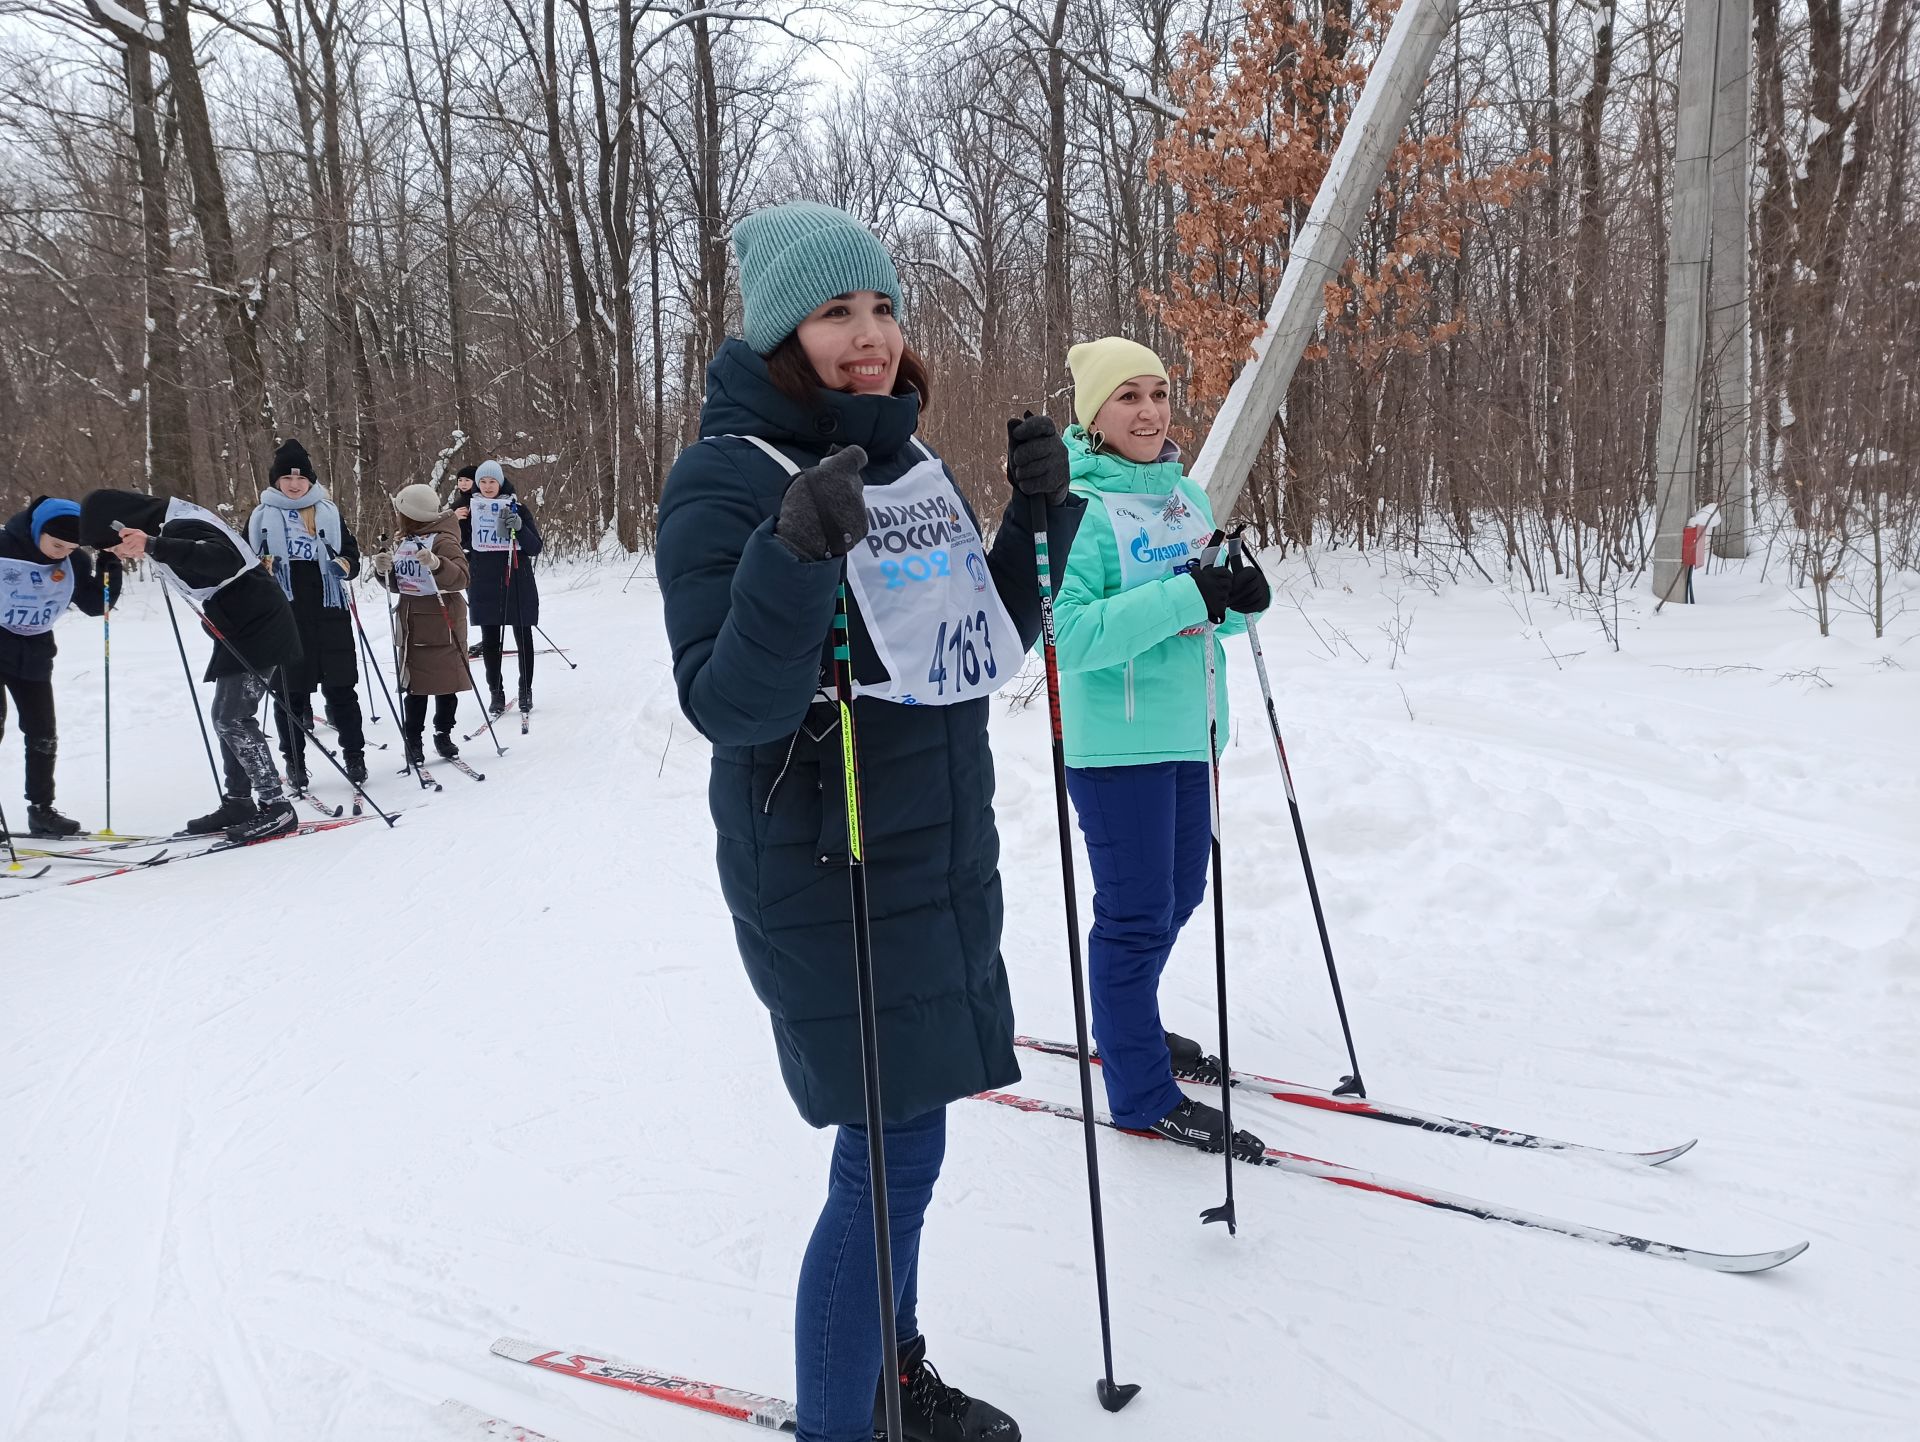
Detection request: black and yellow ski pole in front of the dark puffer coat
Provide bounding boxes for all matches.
[833,574,902,1442]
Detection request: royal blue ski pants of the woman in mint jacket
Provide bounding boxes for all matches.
[1068,760,1213,1127]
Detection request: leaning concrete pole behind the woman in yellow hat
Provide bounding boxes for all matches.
[1192,0,1459,524]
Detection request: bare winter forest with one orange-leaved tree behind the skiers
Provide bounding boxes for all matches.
[0,0,1920,605]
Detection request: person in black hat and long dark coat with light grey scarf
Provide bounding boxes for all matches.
[246,440,367,789]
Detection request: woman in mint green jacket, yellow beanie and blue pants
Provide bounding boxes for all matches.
[1054,336,1271,1154]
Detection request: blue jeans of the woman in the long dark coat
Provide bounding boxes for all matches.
[793,1108,947,1442]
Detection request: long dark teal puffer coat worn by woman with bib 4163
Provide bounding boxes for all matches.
[659,340,1081,1127]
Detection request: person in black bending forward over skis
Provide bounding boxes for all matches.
[81,492,300,841]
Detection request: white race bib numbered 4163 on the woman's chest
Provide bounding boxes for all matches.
[739,436,1023,707]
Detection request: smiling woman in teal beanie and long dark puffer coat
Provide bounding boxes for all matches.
[659,204,1079,1442]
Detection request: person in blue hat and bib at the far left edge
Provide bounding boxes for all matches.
[0,495,121,837]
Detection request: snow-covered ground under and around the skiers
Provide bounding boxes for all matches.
[0,557,1920,1442]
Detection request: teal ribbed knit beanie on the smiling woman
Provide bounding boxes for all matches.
[733,200,900,355]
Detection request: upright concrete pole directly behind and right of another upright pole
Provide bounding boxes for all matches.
[1707,0,1753,557]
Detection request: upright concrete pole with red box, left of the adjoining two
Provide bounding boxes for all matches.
[1653,0,1720,601]
